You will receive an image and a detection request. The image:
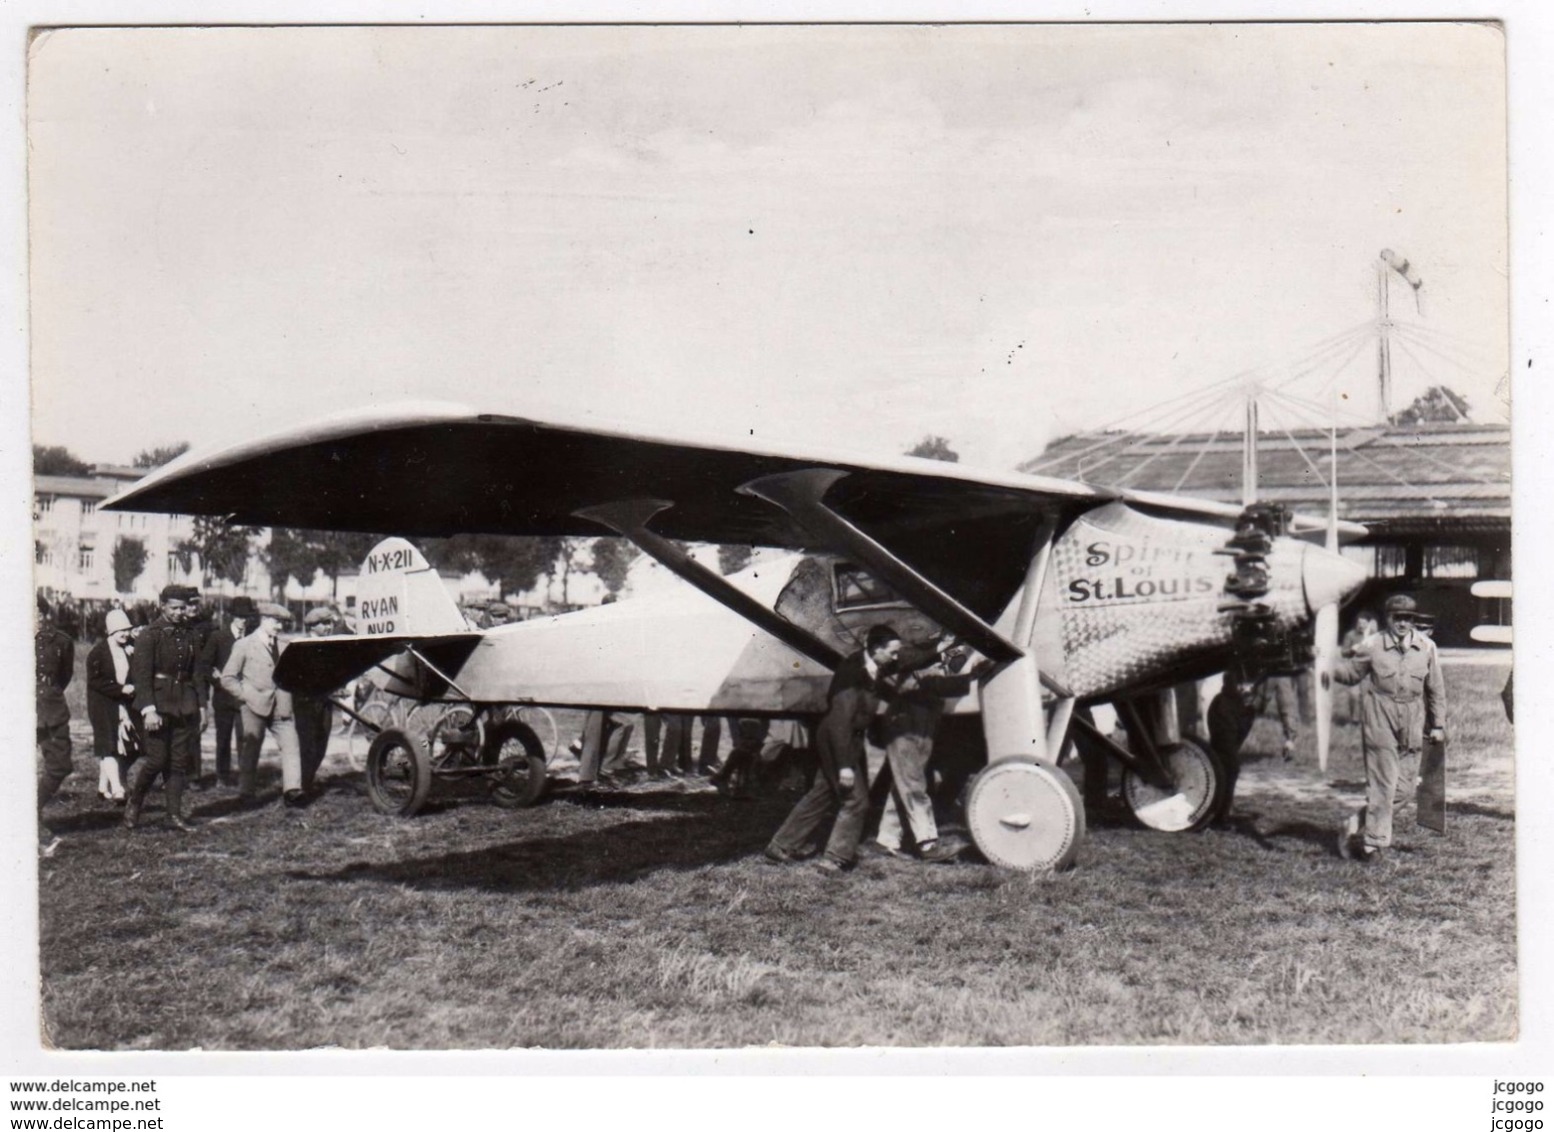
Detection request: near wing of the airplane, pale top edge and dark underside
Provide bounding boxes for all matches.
[106,404,1118,550]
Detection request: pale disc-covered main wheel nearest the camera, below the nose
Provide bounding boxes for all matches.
[967,756,1085,871]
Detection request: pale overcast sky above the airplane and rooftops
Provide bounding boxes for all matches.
[28,23,1507,466]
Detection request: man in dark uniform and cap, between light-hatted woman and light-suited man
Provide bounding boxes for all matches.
[124,586,205,833]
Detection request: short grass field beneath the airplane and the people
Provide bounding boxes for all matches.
[40,666,1517,1050]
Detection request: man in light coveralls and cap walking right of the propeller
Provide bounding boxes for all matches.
[1333,594,1447,863]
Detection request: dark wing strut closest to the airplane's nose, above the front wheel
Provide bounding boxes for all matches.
[738,468,1026,664]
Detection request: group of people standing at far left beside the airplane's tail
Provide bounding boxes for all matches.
[34,585,352,855]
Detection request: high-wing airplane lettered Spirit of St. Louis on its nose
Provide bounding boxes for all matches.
[106,403,1366,869]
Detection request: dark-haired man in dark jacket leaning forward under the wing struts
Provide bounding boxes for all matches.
[766,625,901,872]
